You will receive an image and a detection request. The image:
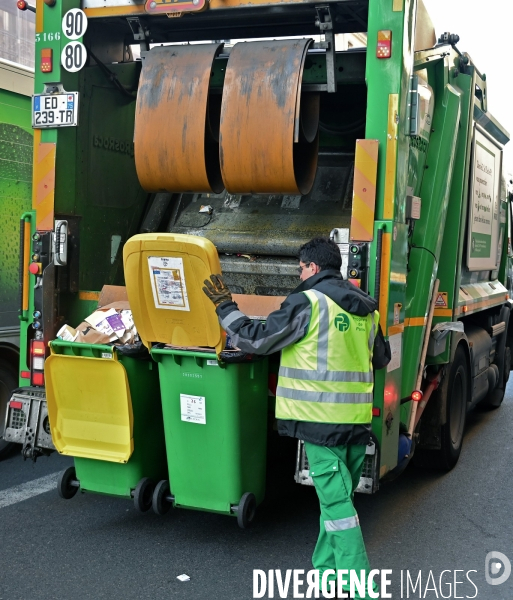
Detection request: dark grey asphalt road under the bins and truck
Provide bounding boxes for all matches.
[0,379,513,600]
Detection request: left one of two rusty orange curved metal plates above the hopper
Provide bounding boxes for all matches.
[134,44,224,193]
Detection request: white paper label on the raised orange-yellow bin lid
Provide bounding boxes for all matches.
[148,256,190,311]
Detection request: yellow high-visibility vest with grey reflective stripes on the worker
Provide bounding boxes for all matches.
[276,290,379,424]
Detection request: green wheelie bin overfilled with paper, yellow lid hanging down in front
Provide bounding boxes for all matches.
[45,340,167,512]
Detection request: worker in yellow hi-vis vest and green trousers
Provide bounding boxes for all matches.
[203,238,390,598]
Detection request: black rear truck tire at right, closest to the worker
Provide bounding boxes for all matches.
[413,346,470,472]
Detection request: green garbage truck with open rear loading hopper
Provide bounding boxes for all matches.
[5,0,513,500]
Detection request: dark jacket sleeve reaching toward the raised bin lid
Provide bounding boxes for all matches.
[216,294,311,354]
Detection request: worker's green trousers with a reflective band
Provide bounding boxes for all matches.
[305,442,377,598]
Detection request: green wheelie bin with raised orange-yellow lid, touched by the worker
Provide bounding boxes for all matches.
[123,233,268,527]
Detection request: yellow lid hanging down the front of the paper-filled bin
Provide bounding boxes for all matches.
[45,349,134,463]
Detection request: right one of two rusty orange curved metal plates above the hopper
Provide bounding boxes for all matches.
[219,39,319,194]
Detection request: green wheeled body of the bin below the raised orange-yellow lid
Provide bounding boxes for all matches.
[151,347,268,528]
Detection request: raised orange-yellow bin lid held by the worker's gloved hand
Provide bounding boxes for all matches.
[123,233,224,354]
